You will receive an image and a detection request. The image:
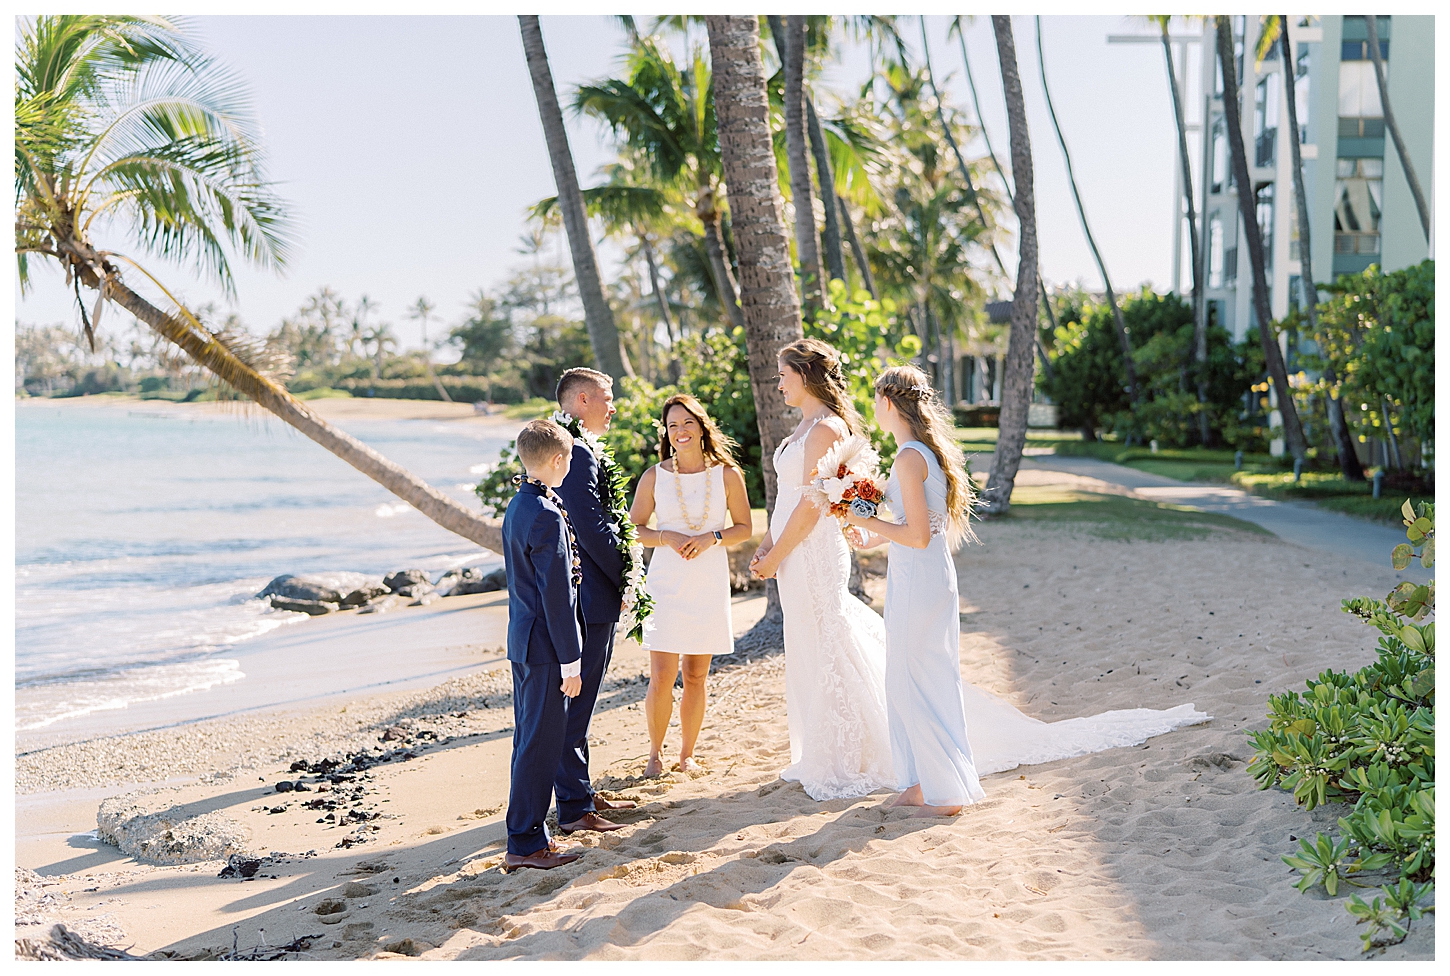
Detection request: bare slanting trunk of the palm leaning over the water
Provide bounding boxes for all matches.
[103,269,503,553]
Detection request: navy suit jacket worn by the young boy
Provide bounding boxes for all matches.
[503,481,584,664]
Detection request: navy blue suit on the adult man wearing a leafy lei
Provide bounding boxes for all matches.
[554,441,625,824]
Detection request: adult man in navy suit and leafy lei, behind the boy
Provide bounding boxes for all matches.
[554,367,634,834]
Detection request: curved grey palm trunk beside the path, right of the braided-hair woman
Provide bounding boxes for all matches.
[980,15,1037,515]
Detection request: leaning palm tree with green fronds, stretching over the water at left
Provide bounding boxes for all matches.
[15,15,502,551]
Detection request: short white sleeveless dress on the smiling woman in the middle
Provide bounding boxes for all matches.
[644,464,734,654]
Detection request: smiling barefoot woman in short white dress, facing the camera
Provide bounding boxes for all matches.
[629,393,751,776]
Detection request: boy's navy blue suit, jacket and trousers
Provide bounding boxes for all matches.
[503,481,584,856]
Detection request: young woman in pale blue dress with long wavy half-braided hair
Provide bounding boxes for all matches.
[847,365,985,816]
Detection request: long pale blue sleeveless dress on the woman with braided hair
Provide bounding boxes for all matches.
[885,441,986,806]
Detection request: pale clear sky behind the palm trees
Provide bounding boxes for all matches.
[12,16,1198,358]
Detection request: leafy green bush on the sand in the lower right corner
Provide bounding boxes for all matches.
[1248,500,1436,951]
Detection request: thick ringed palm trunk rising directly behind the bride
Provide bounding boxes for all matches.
[705,15,802,650]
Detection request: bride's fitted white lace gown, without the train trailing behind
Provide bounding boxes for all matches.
[770,418,895,801]
